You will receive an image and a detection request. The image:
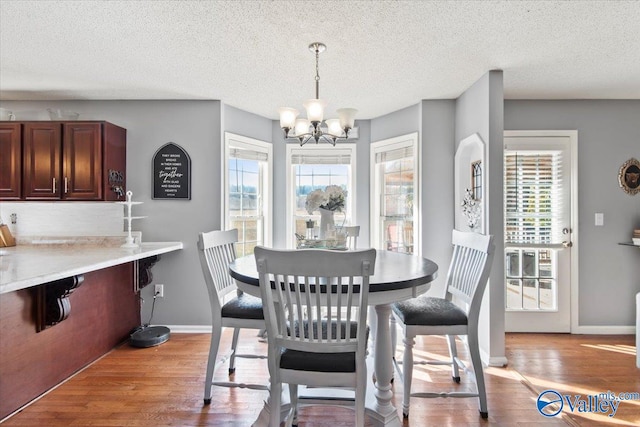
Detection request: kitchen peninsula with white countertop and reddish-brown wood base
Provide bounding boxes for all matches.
[0,238,183,420]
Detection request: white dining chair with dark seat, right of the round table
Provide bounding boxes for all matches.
[391,230,494,418]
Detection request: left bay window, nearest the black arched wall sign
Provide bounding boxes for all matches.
[223,132,273,256]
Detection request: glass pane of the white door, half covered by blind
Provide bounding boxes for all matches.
[504,149,564,310]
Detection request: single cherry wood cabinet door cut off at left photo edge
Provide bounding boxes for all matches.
[0,123,22,200]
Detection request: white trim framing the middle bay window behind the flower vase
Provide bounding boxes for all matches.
[285,142,357,249]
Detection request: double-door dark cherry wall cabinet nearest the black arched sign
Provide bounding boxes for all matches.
[0,121,126,201]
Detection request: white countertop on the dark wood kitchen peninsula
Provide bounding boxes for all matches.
[0,242,183,294]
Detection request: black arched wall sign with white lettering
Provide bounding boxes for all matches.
[153,142,191,200]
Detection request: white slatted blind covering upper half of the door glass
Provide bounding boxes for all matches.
[504,151,563,244]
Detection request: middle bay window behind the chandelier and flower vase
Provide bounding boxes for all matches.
[286,143,356,248]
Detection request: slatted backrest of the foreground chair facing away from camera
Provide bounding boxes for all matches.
[255,247,376,353]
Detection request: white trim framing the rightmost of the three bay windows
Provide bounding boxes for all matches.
[369,132,422,256]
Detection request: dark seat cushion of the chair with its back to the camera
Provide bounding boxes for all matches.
[280,321,369,372]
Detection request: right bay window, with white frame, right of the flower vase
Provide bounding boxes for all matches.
[371,133,420,254]
